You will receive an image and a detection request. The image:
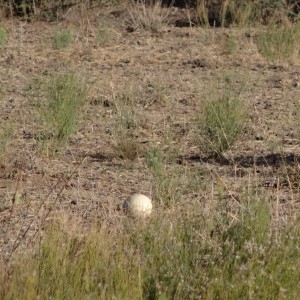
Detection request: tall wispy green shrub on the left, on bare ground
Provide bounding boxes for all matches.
[40,73,87,154]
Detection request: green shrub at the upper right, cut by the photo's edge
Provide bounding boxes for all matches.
[255,21,300,63]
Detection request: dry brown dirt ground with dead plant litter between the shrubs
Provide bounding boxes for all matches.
[0,5,300,258]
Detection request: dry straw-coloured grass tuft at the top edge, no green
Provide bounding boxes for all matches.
[129,0,169,32]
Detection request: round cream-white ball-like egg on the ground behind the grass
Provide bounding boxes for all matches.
[124,194,152,217]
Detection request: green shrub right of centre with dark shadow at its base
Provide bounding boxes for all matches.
[200,94,245,156]
